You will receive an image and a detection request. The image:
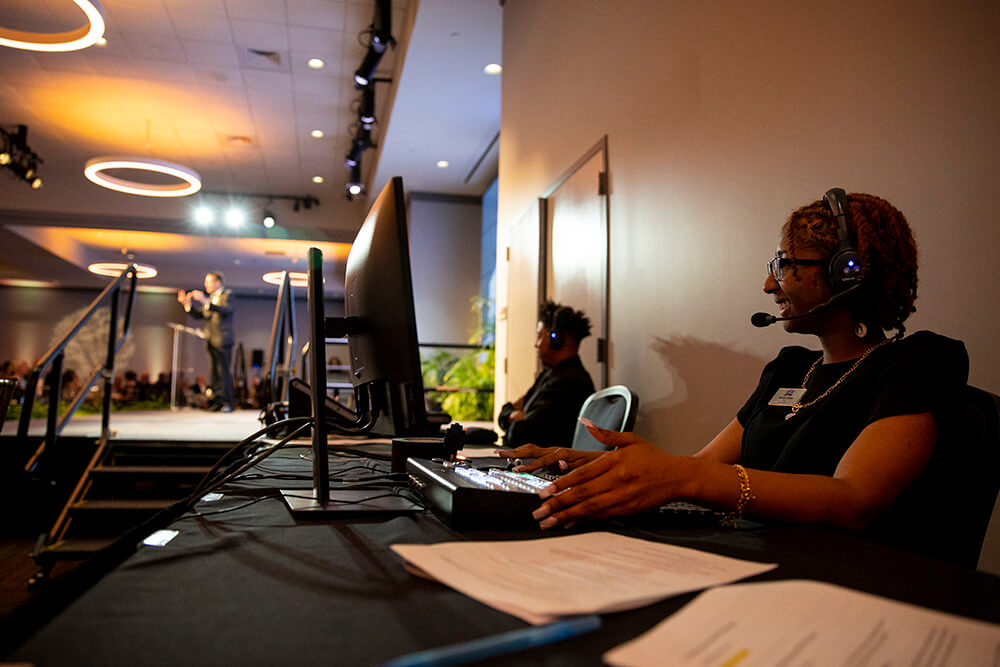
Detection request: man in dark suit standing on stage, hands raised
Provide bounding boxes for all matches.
[177,271,235,412]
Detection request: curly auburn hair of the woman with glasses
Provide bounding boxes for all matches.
[781,192,917,336]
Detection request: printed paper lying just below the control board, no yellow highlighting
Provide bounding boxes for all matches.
[392,532,777,624]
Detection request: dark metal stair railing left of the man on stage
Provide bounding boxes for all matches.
[17,264,136,473]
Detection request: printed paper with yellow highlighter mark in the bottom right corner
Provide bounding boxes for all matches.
[604,580,1000,667]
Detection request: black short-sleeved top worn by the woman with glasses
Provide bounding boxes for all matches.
[737,331,978,564]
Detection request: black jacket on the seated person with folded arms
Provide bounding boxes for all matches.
[497,357,594,447]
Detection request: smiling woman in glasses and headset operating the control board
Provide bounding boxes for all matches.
[499,191,978,565]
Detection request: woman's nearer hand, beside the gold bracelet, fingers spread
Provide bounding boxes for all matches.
[532,421,700,529]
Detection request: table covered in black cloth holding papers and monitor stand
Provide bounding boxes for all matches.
[6,450,1000,666]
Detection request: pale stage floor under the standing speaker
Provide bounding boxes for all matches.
[2,408,263,443]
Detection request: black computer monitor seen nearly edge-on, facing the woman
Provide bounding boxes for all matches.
[344,176,434,436]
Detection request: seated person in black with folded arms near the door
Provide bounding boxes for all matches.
[497,301,594,447]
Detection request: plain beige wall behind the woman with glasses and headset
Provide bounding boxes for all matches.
[497,0,1000,572]
